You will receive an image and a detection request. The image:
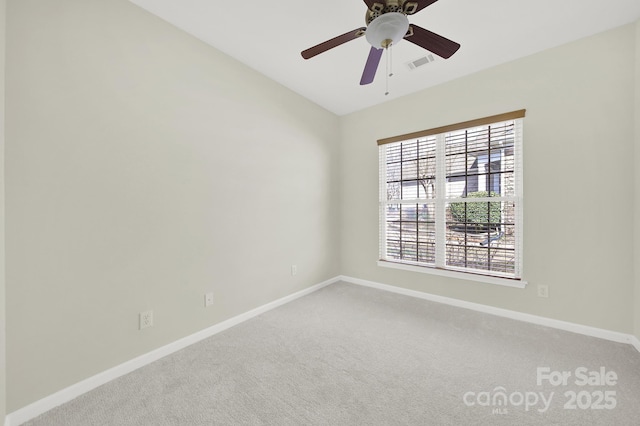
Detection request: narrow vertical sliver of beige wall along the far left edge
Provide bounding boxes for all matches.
[0,0,7,424]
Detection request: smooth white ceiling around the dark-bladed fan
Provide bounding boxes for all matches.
[130,0,640,115]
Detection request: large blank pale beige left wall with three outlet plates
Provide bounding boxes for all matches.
[6,0,339,411]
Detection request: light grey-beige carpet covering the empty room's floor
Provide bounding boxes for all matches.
[22,283,640,426]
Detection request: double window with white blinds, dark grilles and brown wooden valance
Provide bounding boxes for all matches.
[378,110,525,280]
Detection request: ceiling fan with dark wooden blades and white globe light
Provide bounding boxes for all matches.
[301,0,460,85]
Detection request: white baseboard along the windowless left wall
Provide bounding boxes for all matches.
[4,277,340,426]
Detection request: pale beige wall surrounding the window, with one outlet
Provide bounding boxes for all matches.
[340,25,636,333]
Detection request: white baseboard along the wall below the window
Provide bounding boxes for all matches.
[340,275,640,352]
